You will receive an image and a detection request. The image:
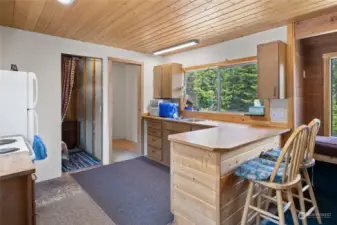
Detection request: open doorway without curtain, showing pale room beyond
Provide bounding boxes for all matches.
[109,58,143,163]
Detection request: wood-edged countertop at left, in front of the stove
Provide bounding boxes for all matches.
[0,152,35,180]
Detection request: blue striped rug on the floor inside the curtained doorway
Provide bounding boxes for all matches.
[62,150,100,172]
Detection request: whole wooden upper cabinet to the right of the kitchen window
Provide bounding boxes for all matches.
[257,41,287,99]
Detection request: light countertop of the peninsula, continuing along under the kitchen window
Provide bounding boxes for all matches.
[143,116,290,151]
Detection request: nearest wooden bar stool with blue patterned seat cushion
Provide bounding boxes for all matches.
[235,125,309,225]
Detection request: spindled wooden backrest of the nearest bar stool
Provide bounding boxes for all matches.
[270,125,309,184]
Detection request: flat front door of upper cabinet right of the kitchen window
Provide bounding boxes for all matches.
[257,42,280,99]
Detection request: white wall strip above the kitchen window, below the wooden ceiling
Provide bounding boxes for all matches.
[164,26,287,67]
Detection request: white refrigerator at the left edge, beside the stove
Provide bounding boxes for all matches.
[0,70,38,145]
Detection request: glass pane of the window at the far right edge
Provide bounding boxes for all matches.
[331,59,337,136]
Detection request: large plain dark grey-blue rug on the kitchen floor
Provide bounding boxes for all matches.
[72,156,173,225]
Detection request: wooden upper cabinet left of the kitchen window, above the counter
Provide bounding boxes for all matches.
[153,63,184,98]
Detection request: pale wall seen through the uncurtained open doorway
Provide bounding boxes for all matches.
[112,62,138,142]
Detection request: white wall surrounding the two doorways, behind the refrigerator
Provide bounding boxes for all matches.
[0,26,163,181]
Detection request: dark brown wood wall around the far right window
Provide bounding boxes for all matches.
[301,33,337,135]
